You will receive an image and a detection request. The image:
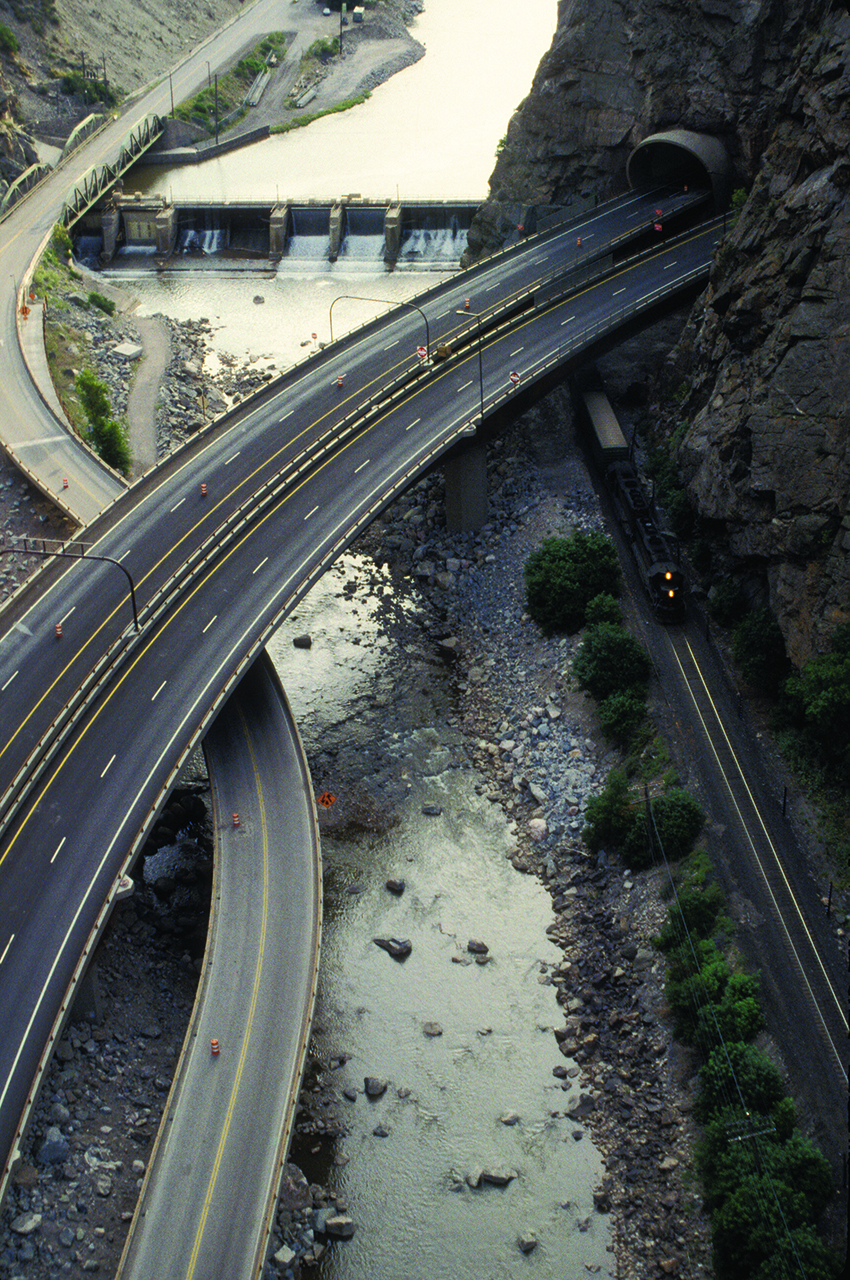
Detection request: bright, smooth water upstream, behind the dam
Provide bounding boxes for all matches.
[133,0,556,200]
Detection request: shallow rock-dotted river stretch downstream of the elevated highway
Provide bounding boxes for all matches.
[269,554,608,1280]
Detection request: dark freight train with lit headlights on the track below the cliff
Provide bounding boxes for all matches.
[576,389,685,622]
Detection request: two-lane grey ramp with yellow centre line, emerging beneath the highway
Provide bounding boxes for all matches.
[118,653,321,1280]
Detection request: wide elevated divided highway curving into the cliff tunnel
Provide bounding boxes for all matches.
[0,195,717,1187]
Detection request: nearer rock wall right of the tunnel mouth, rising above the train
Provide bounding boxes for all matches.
[673,14,850,664]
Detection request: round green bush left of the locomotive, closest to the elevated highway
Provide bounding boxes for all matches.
[525,532,620,634]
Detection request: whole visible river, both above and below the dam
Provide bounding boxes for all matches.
[106,0,611,1280]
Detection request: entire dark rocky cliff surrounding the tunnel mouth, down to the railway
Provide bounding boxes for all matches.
[471,0,850,663]
